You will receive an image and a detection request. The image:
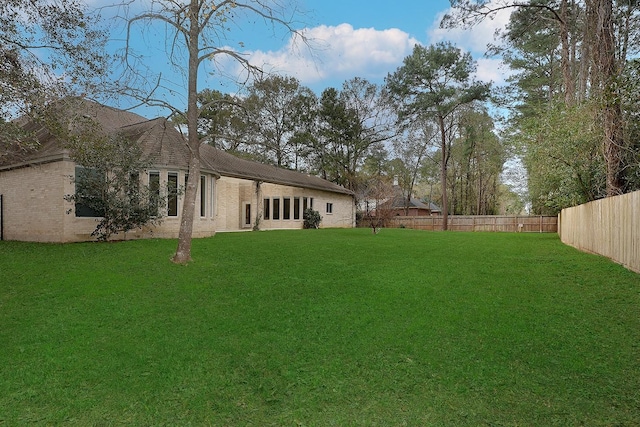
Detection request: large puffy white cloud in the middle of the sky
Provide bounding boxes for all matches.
[216,24,418,85]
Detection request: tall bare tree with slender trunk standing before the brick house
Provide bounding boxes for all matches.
[124,0,298,264]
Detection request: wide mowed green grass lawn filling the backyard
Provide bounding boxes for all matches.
[0,229,640,426]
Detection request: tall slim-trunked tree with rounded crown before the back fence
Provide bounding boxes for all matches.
[386,43,490,230]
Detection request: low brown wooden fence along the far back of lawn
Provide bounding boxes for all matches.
[388,215,558,233]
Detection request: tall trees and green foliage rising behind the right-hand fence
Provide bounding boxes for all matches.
[443,0,640,213]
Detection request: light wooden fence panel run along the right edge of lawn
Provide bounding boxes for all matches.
[559,191,640,273]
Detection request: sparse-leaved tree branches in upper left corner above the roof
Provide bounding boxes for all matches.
[0,0,108,161]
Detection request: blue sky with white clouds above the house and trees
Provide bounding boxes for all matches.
[106,0,508,114]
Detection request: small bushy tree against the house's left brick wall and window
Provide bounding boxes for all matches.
[65,129,165,241]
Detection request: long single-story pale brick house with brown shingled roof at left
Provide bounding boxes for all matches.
[0,98,355,242]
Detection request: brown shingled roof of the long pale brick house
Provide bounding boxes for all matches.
[0,98,353,194]
